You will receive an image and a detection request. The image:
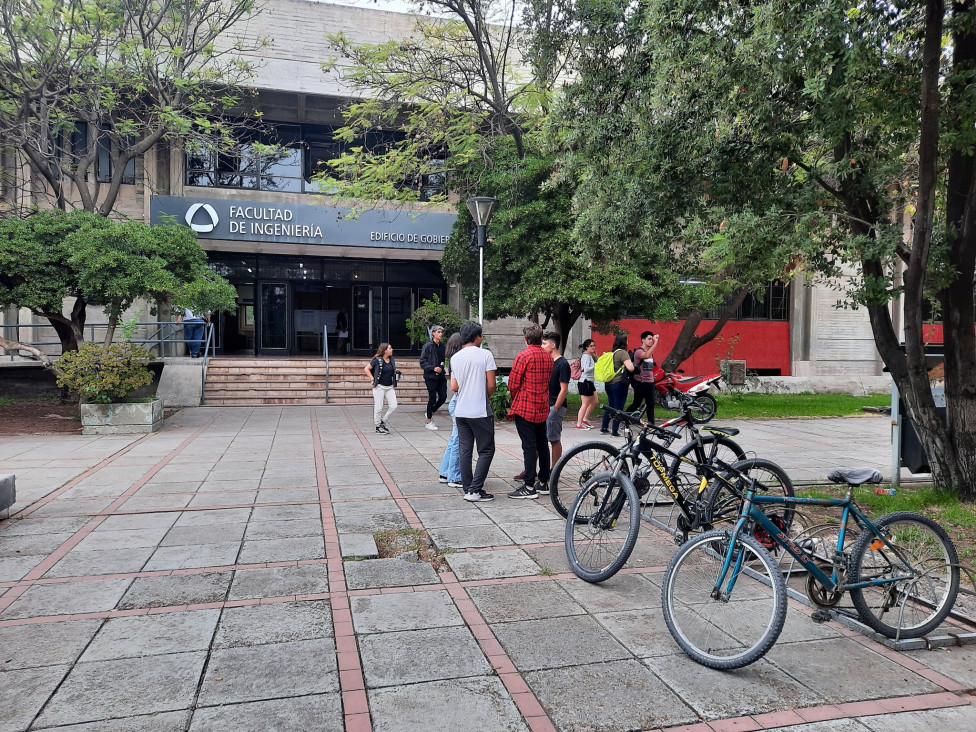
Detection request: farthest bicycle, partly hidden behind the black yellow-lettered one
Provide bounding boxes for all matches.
[549,407,746,518]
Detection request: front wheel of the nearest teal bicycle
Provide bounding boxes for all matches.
[661,530,786,669]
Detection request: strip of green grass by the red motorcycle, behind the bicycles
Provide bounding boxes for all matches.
[566,392,891,423]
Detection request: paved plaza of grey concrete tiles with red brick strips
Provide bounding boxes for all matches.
[0,406,976,732]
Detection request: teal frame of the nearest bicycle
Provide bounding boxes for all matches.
[713,489,908,597]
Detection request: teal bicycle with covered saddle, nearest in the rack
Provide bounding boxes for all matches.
[661,469,959,669]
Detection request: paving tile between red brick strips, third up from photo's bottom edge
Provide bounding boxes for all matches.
[351,591,464,634]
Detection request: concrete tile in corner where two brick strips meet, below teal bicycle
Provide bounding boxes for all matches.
[766,638,940,704]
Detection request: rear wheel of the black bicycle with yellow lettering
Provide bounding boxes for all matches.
[705,458,796,536]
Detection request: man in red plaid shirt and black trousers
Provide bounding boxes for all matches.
[508,324,552,498]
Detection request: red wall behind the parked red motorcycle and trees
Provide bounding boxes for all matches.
[588,318,790,376]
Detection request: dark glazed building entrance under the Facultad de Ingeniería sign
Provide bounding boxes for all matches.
[208,252,447,357]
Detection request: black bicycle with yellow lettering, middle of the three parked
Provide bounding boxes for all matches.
[564,410,793,582]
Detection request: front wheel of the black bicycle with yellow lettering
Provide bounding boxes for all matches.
[566,471,640,582]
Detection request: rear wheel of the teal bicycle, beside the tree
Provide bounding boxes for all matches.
[848,511,959,638]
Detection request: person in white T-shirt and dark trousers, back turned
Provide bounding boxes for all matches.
[451,321,495,502]
